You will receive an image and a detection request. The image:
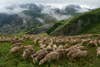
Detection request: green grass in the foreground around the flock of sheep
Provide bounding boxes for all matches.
[0,40,100,67]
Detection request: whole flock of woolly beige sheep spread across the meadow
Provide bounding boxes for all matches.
[0,34,100,65]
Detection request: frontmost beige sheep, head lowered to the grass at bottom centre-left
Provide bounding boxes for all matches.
[39,49,66,65]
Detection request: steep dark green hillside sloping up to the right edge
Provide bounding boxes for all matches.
[47,9,100,35]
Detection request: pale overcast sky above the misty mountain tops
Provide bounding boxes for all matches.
[0,0,100,7]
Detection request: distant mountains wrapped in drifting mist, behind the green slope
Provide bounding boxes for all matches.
[0,3,89,34]
